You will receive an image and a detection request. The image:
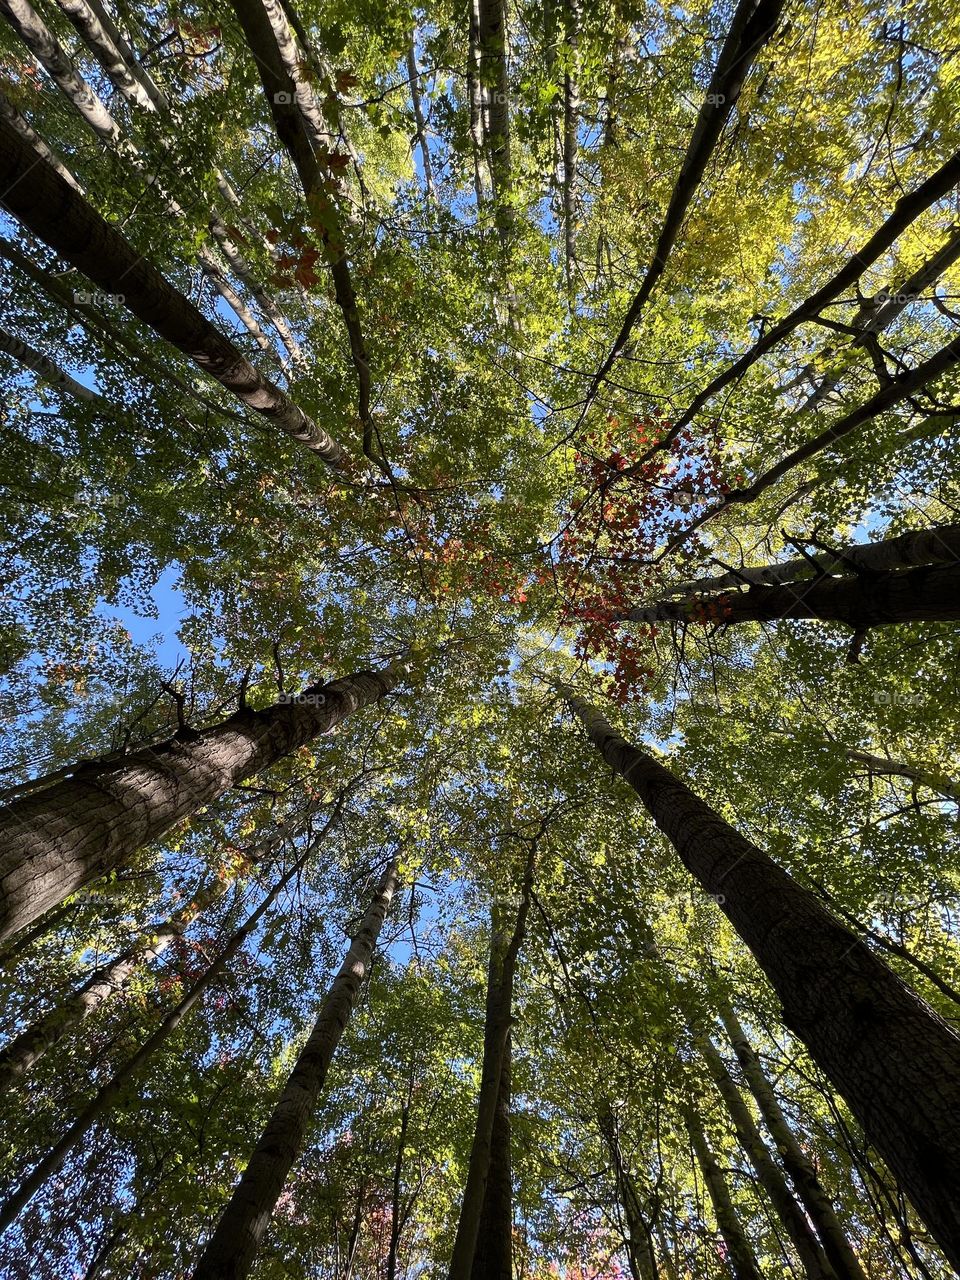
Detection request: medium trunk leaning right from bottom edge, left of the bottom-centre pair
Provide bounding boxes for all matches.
[193,863,397,1280]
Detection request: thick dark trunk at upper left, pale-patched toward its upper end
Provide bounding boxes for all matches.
[0,120,347,467]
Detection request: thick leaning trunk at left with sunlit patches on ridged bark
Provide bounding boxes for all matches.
[0,668,397,937]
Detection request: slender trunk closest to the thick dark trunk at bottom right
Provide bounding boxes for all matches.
[717,995,867,1280]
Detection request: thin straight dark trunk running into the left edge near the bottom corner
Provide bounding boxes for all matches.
[0,837,320,1231]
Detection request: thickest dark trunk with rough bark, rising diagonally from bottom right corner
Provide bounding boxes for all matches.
[564,690,960,1266]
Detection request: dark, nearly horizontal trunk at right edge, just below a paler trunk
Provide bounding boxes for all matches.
[617,561,960,631]
